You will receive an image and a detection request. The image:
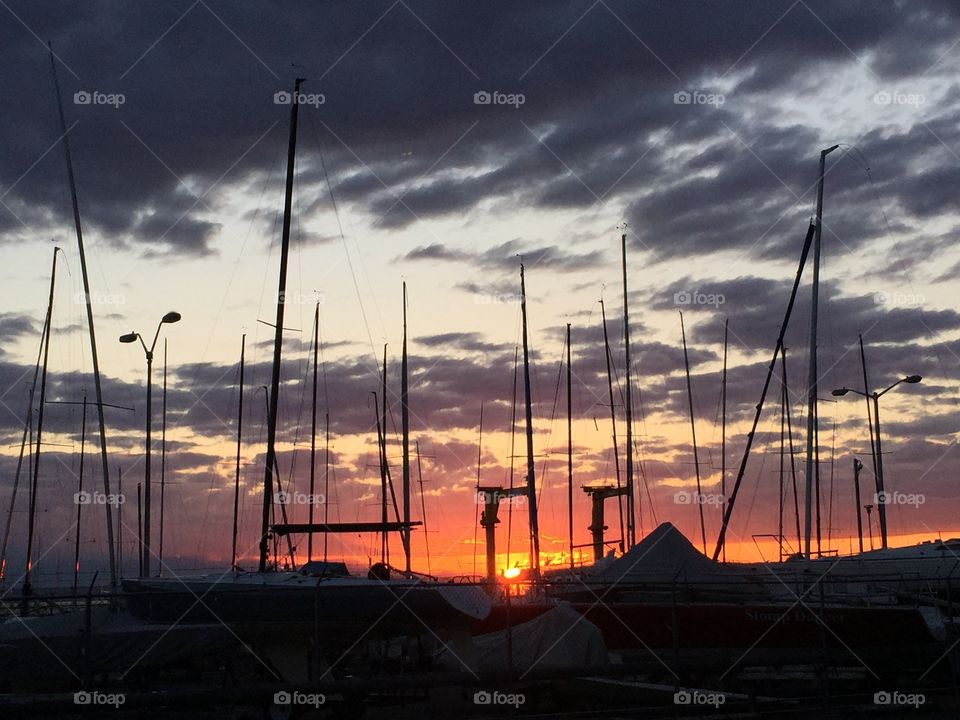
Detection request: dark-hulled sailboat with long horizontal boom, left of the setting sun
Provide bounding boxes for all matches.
[123,78,490,644]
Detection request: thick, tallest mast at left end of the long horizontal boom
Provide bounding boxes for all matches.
[259,78,303,572]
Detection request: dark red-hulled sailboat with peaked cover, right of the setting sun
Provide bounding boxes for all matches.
[532,207,944,666]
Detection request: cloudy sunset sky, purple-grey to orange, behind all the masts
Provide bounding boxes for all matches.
[0,0,960,577]
